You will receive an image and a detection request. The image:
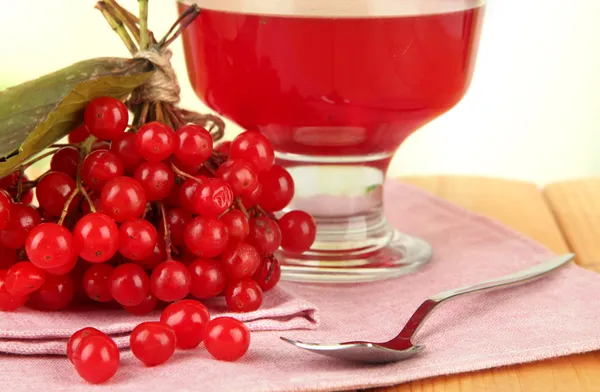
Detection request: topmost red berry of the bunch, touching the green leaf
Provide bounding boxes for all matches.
[83,97,129,140]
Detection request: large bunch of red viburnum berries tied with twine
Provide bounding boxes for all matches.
[0,97,316,314]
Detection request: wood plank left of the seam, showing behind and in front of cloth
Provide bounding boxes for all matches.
[370,176,600,392]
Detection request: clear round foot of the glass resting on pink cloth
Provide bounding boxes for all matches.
[278,230,433,283]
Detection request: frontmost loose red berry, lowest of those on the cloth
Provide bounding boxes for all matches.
[73,334,121,384]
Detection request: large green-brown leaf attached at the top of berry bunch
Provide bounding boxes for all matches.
[0,57,153,177]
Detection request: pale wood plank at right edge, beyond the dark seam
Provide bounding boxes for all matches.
[544,179,600,272]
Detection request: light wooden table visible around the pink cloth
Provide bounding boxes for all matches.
[379,176,600,392]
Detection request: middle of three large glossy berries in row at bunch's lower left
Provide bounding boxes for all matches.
[73,212,119,263]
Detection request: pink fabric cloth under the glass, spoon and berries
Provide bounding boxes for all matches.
[0,182,600,392]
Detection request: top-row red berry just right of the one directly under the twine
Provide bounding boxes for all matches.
[174,124,213,166]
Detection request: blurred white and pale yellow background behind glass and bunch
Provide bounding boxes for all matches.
[0,0,600,184]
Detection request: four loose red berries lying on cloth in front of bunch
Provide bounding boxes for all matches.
[67,300,250,384]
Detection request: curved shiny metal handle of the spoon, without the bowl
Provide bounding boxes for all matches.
[393,253,575,340]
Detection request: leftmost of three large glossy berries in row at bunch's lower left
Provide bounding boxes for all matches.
[25,223,77,269]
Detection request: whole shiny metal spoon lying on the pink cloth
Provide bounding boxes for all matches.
[281,253,575,363]
